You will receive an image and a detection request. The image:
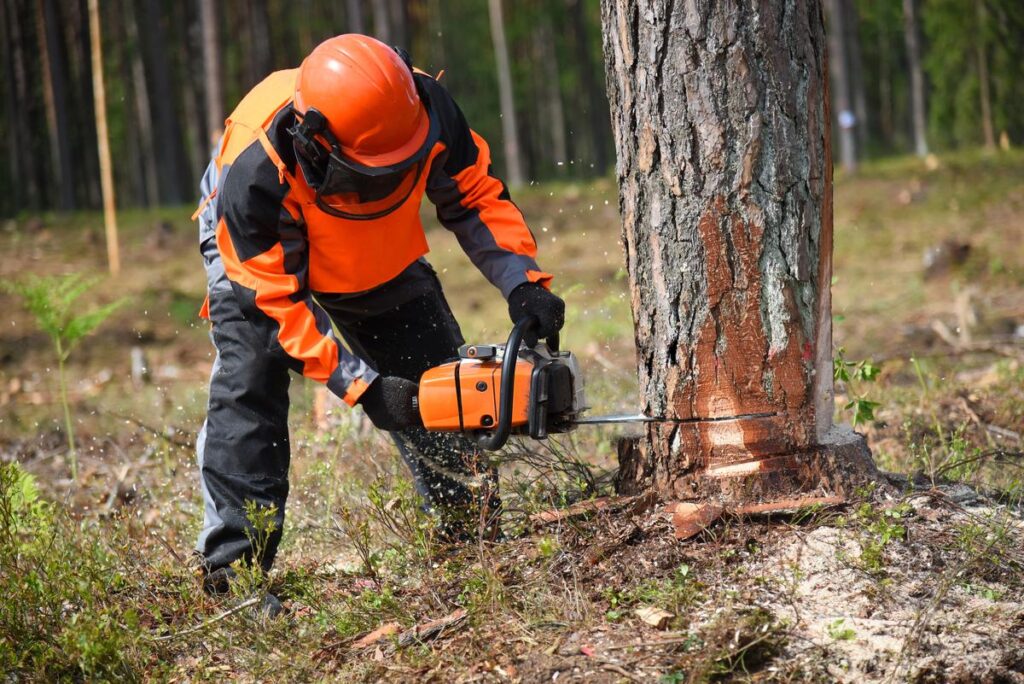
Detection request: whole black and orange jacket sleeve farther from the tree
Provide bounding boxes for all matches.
[216,144,377,405]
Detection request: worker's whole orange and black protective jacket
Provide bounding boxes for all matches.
[197,70,551,404]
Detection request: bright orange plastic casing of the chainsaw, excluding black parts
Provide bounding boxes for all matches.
[419,358,534,432]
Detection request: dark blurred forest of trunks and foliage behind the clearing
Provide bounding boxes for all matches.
[0,0,1024,216]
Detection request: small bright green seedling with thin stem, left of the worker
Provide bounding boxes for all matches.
[3,273,127,479]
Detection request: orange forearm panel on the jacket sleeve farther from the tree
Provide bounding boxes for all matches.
[217,219,338,383]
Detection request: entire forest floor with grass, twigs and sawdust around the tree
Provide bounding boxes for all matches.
[0,152,1024,682]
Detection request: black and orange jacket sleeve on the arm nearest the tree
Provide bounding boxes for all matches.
[421,77,552,299]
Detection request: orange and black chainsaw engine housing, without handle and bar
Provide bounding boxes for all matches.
[419,343,586,438]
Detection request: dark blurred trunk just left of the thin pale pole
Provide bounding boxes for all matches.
[36,0,75,211]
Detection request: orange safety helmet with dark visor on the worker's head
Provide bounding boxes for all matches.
[290,34,439,219]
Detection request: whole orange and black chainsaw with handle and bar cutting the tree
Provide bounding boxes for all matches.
[417,316,657,451]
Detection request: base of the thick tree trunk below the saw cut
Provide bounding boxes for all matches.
[615,426,885,513]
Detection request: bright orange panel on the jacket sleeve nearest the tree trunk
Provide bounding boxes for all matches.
[453,131,537,259]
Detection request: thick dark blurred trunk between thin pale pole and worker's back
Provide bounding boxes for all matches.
[140,0,186,205]
